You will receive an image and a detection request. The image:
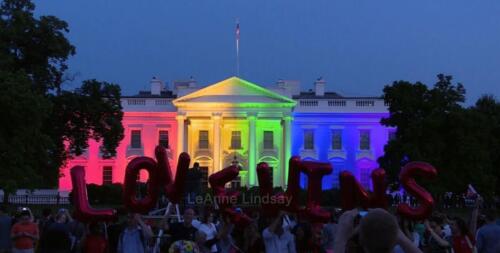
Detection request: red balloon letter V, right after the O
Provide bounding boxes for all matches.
[155,146,191,204]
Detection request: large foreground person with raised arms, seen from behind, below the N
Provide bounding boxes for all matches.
[333,209,422,253]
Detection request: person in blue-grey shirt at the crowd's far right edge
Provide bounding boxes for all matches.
[476,209,500,253]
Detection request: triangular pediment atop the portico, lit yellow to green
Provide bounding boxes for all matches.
[173,77,296,107]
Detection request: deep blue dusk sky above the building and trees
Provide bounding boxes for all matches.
[35,0,500,104]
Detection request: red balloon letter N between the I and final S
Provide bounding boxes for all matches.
[340,169,387,210]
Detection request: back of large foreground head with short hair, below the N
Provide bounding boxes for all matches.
[359,209,398,253]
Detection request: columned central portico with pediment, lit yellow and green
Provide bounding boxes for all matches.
[173,77,296,187]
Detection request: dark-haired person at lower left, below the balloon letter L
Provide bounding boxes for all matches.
[39,209,71,253]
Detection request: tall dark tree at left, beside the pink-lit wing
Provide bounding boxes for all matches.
[0,0,123,189]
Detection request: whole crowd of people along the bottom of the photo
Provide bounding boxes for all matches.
[0,198,500,253]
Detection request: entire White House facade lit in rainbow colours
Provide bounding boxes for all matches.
[59,77,395,190]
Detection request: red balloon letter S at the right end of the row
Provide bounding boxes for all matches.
[397,162,437,220]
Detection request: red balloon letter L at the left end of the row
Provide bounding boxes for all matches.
[71,166,117,223]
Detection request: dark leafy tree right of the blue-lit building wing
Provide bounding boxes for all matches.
[379,74,500,195]
